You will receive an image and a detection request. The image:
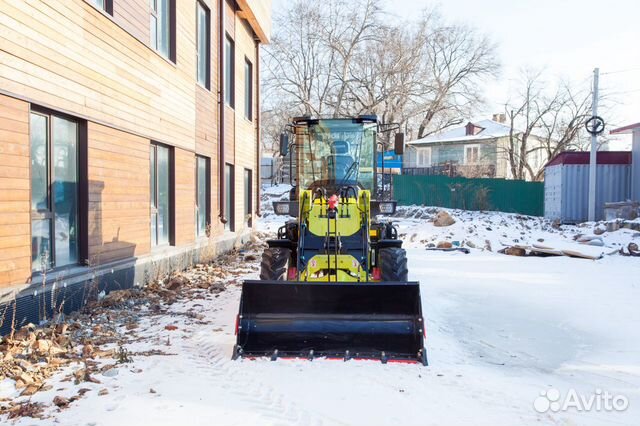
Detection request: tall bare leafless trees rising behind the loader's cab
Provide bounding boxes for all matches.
[263,0,498,146]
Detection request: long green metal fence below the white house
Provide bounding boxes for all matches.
[393,175,544,216]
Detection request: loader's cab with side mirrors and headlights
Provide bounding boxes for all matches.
[273,115,404,216]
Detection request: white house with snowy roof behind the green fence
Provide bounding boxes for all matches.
[402,114,547,179]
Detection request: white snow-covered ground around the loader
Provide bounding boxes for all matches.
[0,188,640,426]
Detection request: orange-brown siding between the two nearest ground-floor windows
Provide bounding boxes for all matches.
[88,123,151,264]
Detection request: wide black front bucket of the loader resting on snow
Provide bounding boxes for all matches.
[234,281,427,365]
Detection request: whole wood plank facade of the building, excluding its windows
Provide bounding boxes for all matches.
[0,0,268,287]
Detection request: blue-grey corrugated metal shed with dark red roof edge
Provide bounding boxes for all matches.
[544,151,631,223]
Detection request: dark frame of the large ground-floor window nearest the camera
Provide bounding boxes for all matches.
[29,104,89,276]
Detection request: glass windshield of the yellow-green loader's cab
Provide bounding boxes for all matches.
[295,119,377,191]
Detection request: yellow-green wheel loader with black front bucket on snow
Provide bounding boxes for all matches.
[233,116,427,365]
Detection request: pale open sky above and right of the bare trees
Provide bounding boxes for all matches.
[273,0,640,144]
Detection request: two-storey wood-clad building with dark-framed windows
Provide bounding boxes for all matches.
[0,0,271,332]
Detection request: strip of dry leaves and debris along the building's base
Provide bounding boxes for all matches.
[0,241,263,419]
